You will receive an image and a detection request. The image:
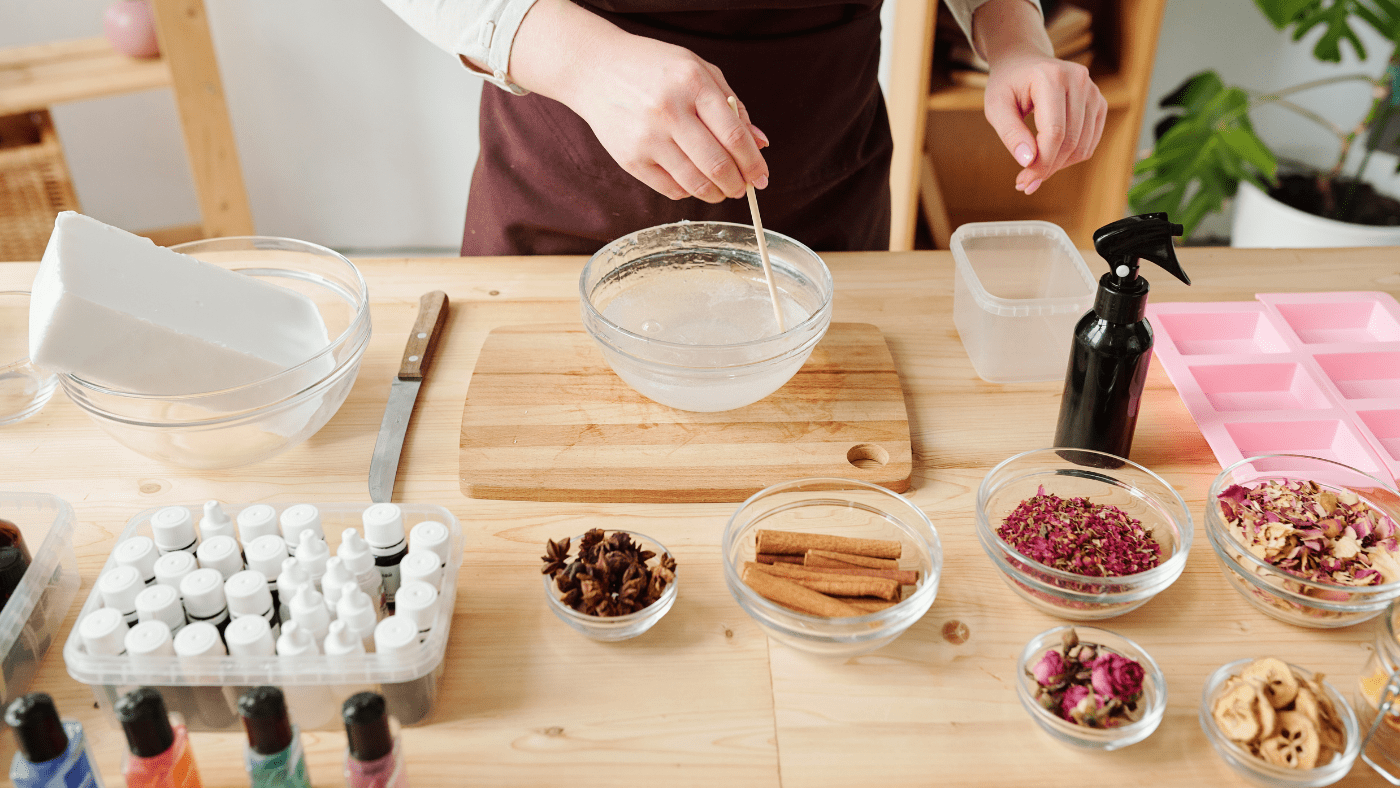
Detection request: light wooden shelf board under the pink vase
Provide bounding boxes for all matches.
[0,36,171,115]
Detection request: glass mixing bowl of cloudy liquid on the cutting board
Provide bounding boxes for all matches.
[578,221,832,411]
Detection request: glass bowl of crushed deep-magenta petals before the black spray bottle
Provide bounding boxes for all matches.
[976,449,1194,621]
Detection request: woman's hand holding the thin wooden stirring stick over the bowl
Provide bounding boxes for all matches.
[510,0,769,203]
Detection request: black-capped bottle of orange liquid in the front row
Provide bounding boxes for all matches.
[115,687,202,788]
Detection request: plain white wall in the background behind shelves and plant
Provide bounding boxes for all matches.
[8,0,1400,251]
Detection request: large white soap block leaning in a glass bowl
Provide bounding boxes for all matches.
[29,211,329,395]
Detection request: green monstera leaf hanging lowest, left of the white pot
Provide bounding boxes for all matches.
[1128,71,1278,237]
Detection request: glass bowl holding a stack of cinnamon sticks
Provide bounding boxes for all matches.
[721,479,944,658]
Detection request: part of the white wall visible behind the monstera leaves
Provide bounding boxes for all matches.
[1138,0,1400,235]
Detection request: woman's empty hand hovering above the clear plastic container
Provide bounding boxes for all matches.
[973,0,1109,195]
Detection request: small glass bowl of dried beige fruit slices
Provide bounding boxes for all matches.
[1198,656,1362,788]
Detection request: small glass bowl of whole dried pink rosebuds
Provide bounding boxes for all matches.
[1016,627,1166,750]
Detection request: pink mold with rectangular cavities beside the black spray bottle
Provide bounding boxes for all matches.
[1147,293,1400,479]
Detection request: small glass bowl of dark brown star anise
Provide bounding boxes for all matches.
[542,528,676,641]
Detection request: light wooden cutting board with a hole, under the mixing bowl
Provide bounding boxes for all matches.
[461,323,913,502]
